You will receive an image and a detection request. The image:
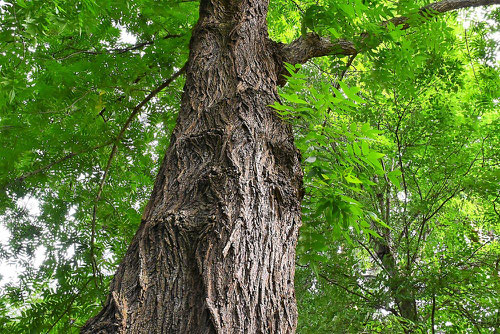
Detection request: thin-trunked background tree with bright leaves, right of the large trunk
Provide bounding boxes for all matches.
[296,41,500,333]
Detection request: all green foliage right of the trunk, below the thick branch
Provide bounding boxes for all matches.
[286,5,500,333]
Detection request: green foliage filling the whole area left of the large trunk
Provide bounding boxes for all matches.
[0,0,191,333]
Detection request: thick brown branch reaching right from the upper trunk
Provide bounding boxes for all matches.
[280,0,500,64]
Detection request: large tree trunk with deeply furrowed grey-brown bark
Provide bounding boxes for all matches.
[82,0,302,333]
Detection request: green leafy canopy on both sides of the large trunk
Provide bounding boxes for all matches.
[0,0,500,333]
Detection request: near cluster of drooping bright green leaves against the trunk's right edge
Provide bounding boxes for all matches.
[272,64,387,262]
